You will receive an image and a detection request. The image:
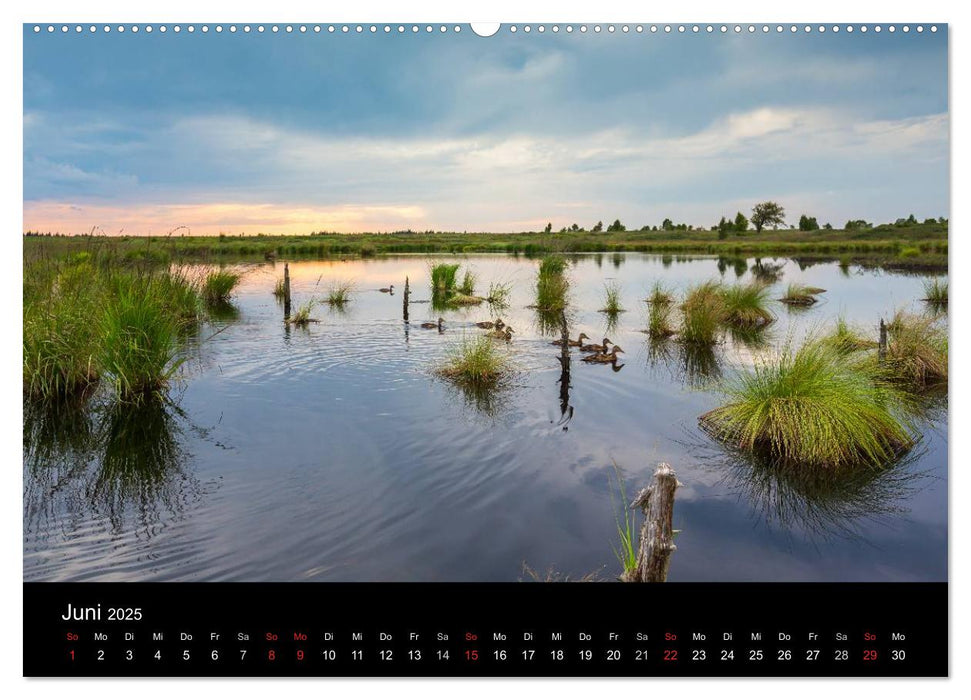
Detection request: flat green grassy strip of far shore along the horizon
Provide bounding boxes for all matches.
[23,220,948,271]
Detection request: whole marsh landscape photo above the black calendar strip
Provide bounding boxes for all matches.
[22,23,950,592]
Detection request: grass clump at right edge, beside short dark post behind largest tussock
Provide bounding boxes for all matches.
[884,311,948,391]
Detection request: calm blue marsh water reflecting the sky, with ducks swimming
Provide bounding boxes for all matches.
[24,254,948,581]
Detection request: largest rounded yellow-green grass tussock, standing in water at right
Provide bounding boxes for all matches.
[699,340,914,470]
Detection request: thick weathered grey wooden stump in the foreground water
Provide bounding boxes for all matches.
[623,462,679,583]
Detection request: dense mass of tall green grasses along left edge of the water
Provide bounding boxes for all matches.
[23,252,240,404]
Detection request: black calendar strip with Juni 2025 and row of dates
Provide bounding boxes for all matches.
[24,583,948,677]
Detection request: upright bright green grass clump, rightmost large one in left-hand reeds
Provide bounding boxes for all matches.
[97,277,182,403]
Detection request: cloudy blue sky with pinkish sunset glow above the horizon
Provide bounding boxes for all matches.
[24,25,949,235]
